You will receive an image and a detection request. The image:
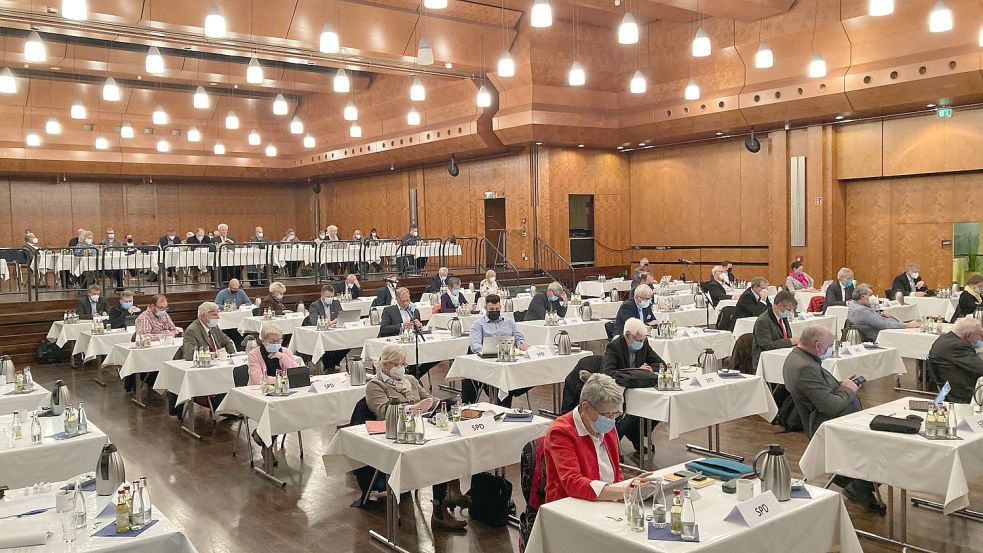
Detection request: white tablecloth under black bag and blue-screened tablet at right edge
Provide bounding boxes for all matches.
[799,398,983,514]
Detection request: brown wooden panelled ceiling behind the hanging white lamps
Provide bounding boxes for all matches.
[0,0,983,179]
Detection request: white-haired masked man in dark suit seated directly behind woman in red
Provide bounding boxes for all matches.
[601,317,663,460]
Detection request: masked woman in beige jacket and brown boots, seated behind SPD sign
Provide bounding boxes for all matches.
[365,344,471,530]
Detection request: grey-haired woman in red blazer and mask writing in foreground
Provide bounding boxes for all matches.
[545,374,624,502]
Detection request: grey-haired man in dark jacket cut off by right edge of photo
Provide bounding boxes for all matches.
[928,317,983,403]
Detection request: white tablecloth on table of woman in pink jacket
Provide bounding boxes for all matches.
[216,373,365,444]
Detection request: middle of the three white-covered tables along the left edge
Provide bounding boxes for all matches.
[0,413,106,488]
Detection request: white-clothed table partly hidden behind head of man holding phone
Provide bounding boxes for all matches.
[756,346,908,384]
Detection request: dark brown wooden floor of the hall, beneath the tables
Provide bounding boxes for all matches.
[26,354,983,553]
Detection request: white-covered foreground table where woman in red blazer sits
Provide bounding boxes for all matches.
[526,465,863,553]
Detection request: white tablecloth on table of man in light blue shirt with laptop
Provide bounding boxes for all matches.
[447,351,591,399]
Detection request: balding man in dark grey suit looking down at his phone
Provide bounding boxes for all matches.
[782,325,886,516]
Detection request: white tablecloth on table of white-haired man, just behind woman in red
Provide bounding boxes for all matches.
[625,367,778,440]
